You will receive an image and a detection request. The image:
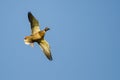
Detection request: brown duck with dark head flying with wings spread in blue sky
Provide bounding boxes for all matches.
[24,12,52,60]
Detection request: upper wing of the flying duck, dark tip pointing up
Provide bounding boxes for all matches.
[28,12,40,34]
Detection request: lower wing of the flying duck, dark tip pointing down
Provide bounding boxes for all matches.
[38,39,52,60]
